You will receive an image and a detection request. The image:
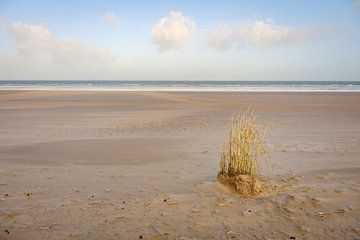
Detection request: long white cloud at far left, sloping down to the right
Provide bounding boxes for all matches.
[10,22,117,63]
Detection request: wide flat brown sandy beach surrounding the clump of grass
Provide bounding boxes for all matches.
[0,91,360,239]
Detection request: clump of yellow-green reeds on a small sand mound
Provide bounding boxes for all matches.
[218,108,266,194]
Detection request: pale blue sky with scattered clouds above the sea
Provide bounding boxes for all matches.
[0,0,360,81]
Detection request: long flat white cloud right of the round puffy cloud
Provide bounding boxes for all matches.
[209,19,313,48]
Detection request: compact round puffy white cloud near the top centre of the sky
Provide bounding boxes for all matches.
[152,11,195,50]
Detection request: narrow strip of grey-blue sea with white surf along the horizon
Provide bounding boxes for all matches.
[0,80,360,92]
